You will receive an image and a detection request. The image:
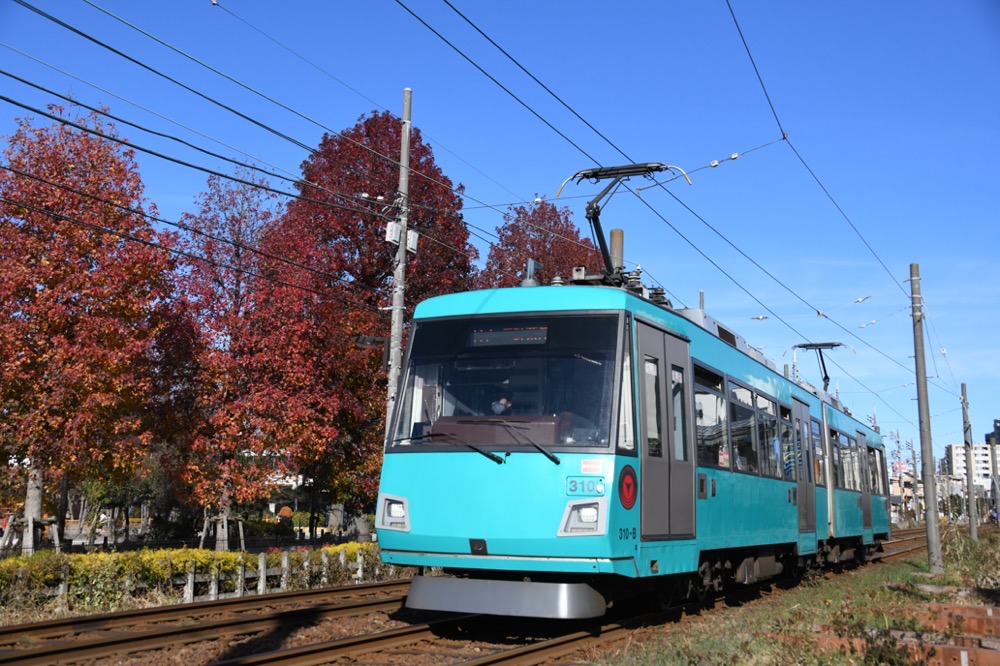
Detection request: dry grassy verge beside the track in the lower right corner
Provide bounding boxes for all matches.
[603,529,1000,666]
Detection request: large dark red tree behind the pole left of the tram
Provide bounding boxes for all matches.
[253,113,476,508]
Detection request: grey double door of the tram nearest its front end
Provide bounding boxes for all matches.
[637,322,694,539]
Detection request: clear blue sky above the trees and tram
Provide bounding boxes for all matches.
[0,0,1000,466]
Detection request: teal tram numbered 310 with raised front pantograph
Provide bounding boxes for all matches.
[375,162,890,619]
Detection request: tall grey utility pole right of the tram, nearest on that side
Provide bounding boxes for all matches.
[910,264,944,574]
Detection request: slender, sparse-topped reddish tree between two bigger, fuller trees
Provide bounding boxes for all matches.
[173,168,285,536]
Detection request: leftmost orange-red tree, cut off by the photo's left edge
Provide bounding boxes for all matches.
[0,107,171,548]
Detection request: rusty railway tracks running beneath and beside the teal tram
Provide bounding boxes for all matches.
[0,530,926,666]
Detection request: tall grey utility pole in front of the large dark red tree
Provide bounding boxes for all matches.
[385,88,413,430]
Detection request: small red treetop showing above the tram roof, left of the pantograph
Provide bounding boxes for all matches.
[479,200,603,288]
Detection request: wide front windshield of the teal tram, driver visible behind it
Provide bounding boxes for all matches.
[389,315,619,449]
